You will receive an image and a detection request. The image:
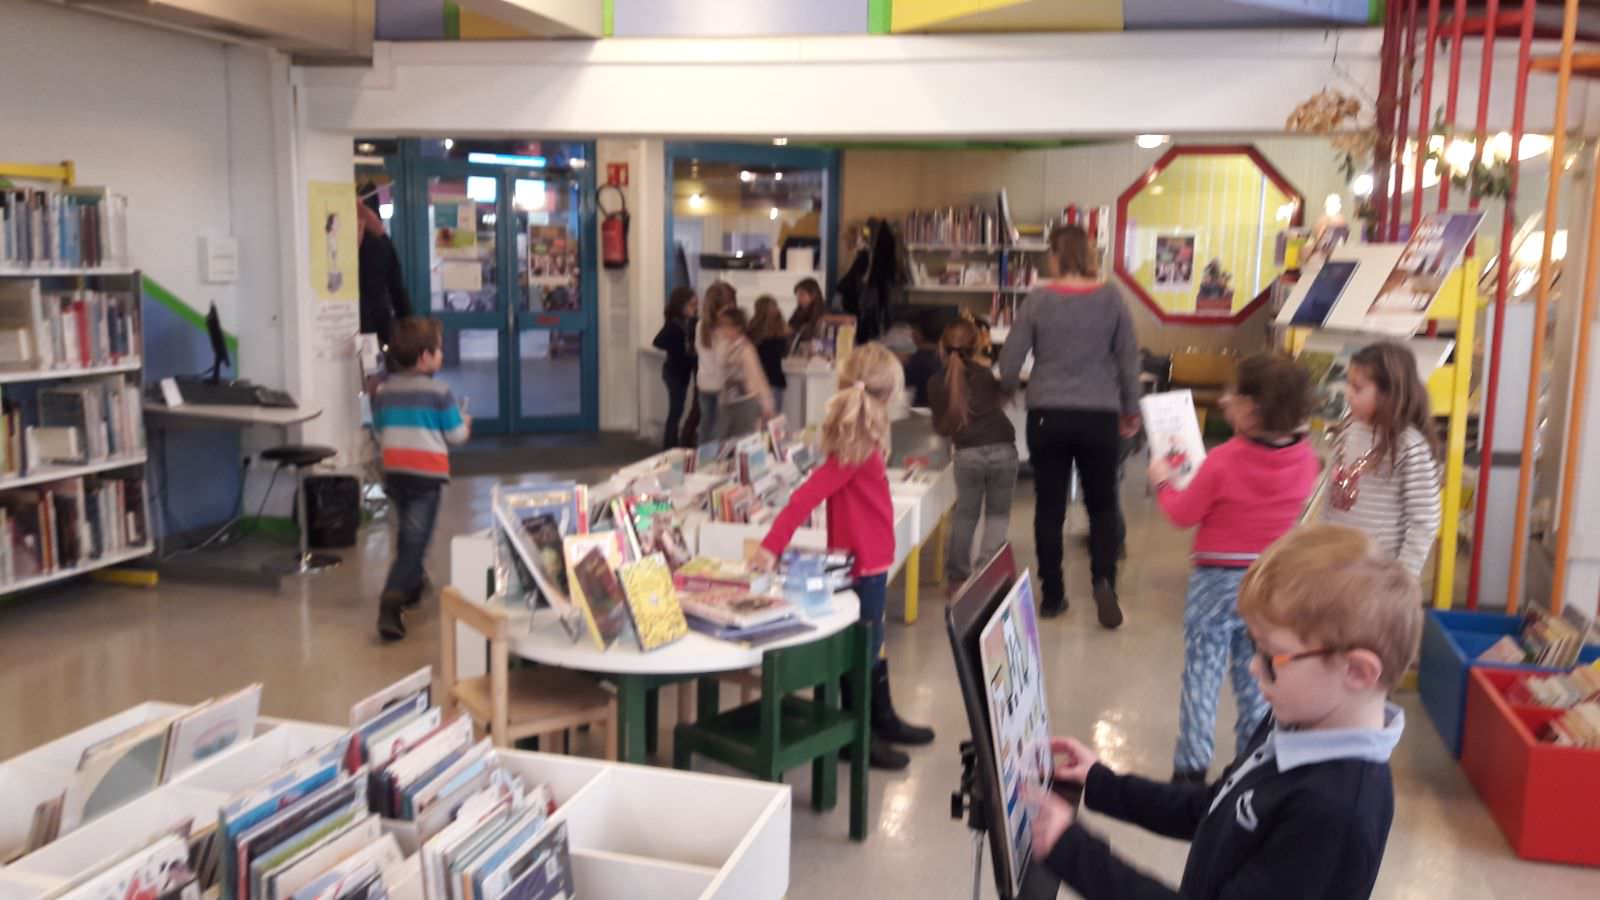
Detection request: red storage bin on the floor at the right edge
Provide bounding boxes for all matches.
[1461,668,1600,866]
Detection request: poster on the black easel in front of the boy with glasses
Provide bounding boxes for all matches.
[978,572,1054,895]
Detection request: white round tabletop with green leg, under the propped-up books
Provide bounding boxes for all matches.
[510,591,861,762]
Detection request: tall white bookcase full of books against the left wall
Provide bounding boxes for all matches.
[0,162,154,596]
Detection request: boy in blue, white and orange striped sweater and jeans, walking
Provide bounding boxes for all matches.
[373,317,472,641]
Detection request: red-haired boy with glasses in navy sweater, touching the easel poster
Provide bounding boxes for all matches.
[1034,525,1422,900]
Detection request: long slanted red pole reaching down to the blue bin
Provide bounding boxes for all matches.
[1467,0,1536,610]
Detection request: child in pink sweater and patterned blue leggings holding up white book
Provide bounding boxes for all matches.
[1150,354,1318,783]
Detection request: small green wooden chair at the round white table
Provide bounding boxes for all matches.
[672,625,870,841]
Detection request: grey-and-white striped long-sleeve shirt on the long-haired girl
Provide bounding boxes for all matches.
[1323,421,1440,575]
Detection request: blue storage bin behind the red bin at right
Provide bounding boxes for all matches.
[1418,610,1600,759]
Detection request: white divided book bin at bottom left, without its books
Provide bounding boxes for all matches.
[0,703,790,900]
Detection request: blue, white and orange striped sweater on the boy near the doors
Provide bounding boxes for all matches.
[373,372,467,480]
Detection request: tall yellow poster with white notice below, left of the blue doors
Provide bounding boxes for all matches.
[306,181,362,360]
